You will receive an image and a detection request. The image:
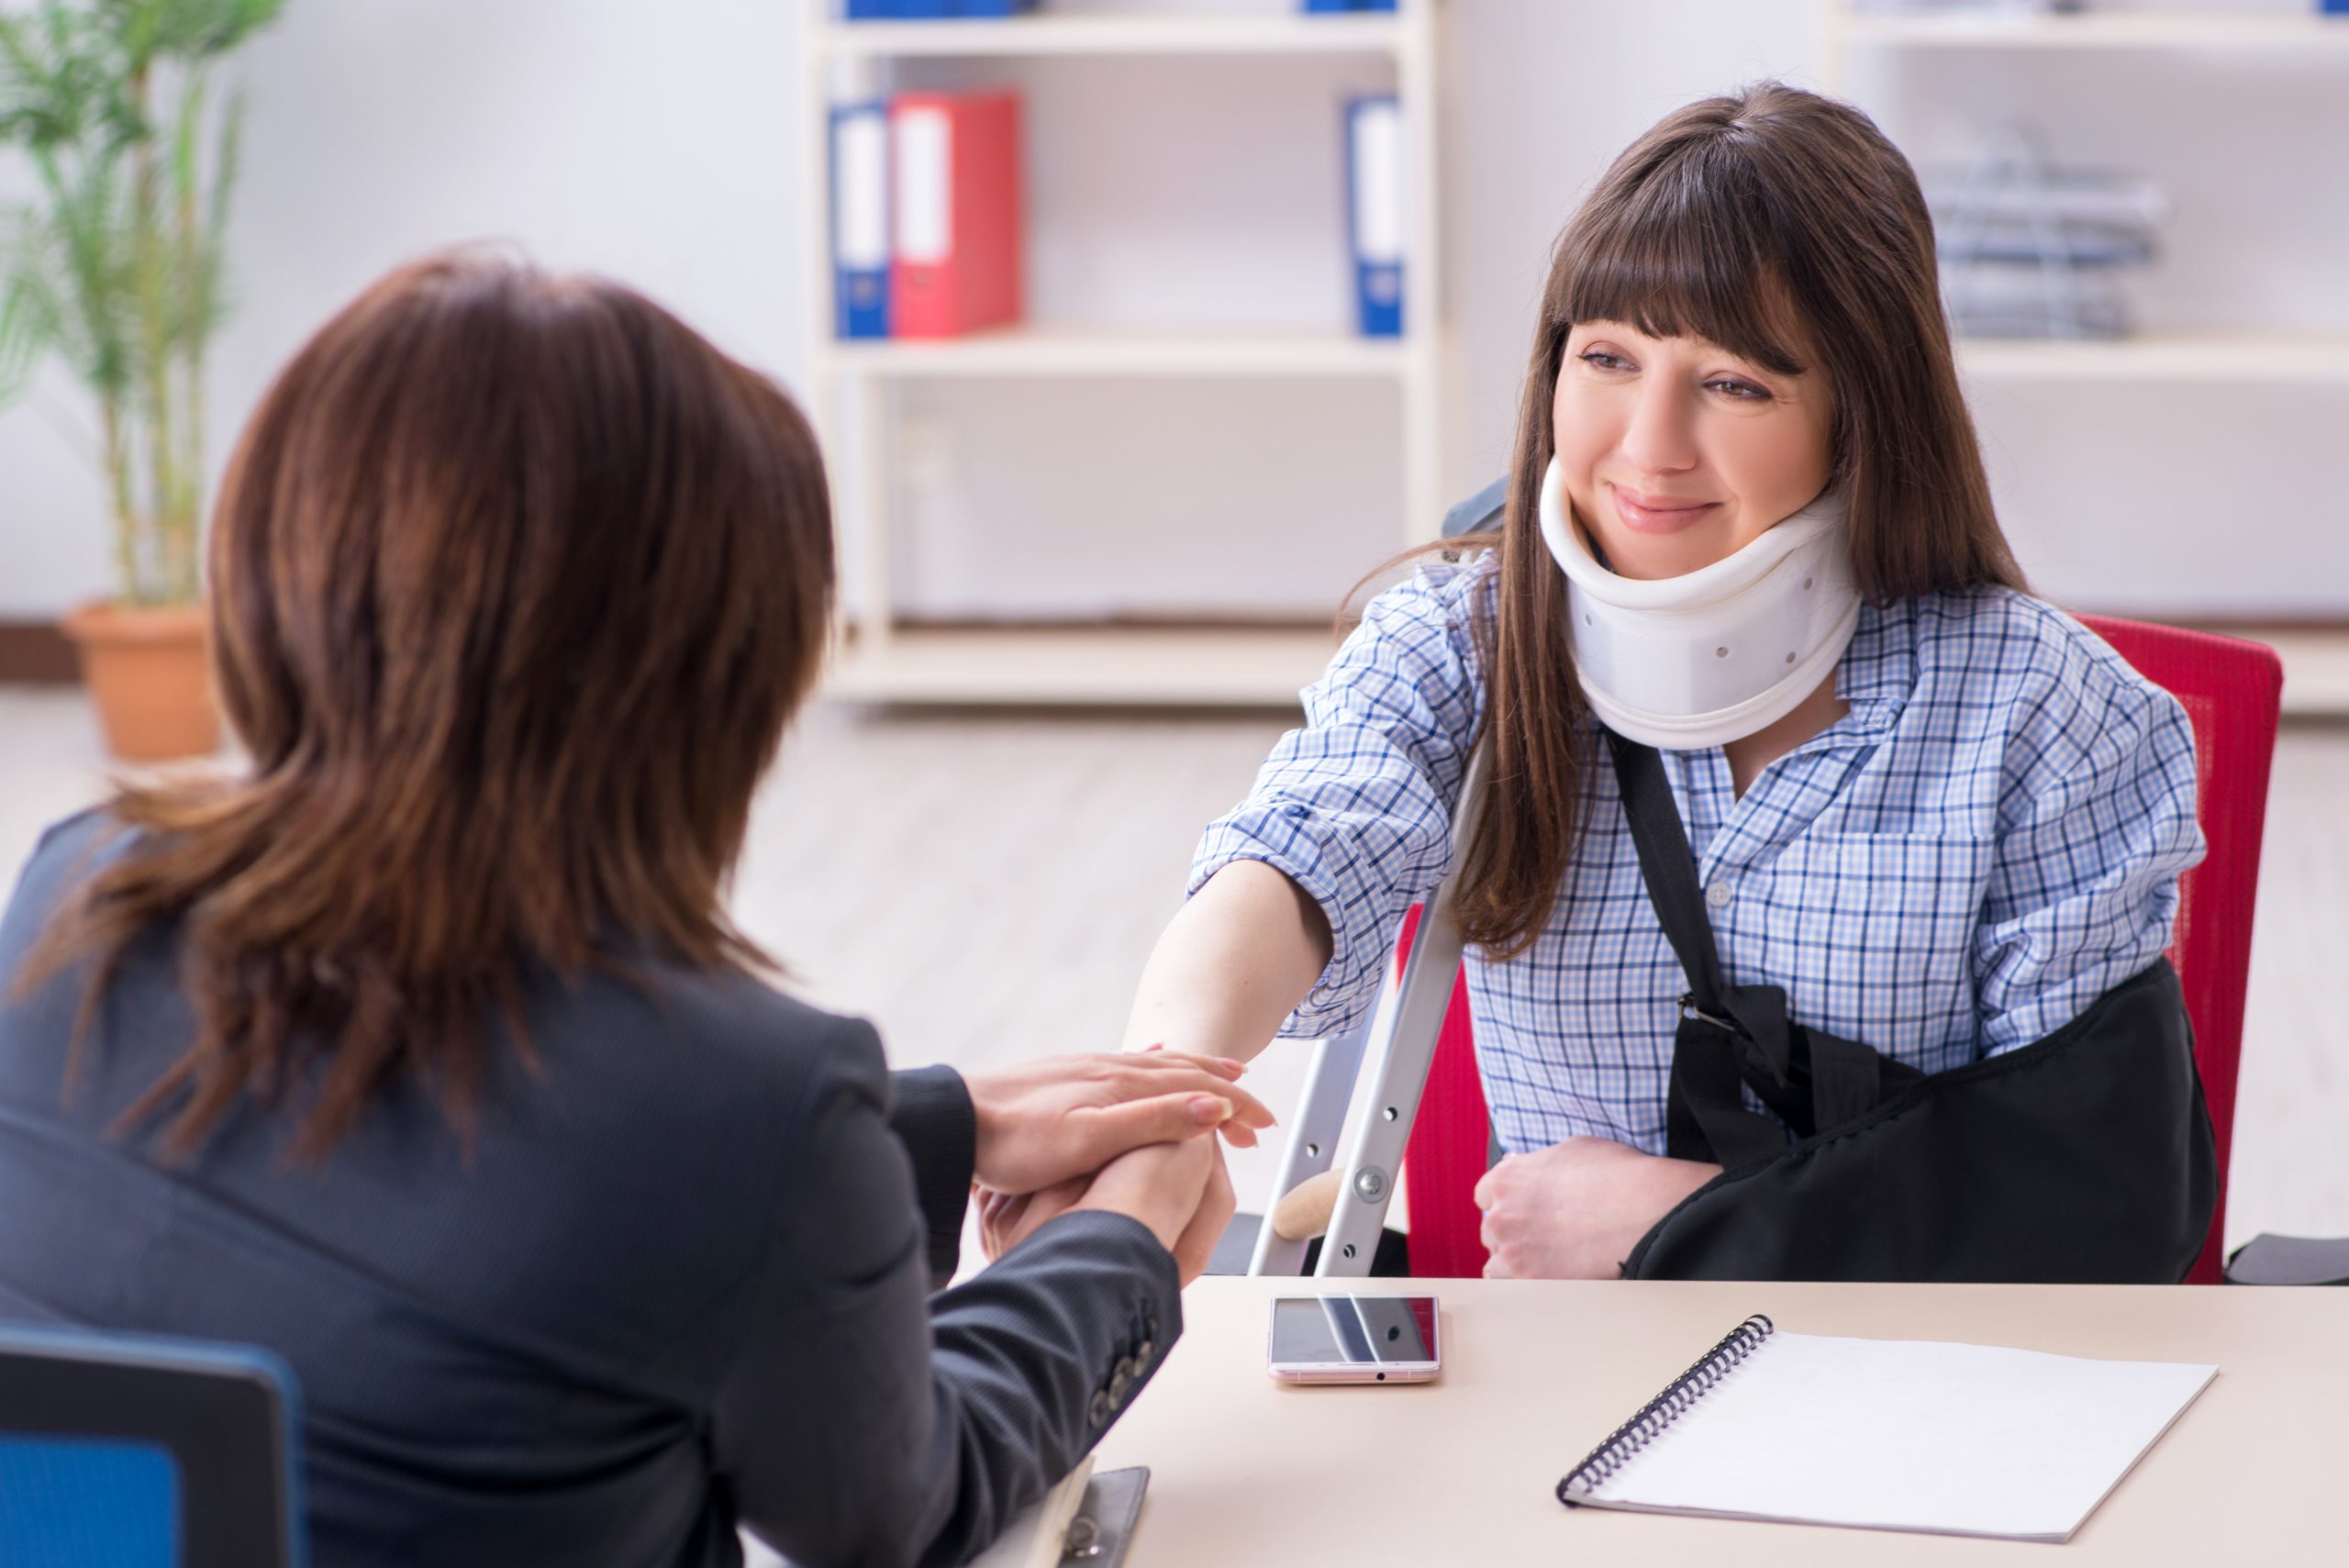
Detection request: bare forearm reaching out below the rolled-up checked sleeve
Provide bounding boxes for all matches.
[1125,859,1330,1061]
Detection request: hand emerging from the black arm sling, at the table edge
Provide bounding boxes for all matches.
[1475,1139,1721,1279]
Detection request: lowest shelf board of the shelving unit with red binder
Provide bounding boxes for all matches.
[819,627,1337,711]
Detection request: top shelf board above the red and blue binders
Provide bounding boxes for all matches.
[818,12,1405,59]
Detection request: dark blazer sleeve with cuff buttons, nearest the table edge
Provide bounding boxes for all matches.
[712,1021,1182,1568]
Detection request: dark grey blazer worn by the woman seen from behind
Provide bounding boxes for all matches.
[0,815,1182,1568]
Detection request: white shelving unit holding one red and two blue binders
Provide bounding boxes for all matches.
[801,0,1444,706]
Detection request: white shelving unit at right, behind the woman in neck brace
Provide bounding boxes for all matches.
[1813,0,2349,716]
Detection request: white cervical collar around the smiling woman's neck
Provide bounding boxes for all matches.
[1539,458,1861,751]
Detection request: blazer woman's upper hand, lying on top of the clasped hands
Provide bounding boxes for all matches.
[963,1051,1274,1195]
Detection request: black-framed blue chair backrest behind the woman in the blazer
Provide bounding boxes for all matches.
[0,1324,306,1568]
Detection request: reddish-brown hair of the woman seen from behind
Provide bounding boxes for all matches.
[9,253,834,1157]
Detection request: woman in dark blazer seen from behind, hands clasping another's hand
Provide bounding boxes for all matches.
[0,258,1268,1568]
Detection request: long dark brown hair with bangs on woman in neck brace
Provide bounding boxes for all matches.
[1452,83,2022,958]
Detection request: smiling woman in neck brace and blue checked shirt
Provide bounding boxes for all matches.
[1108,84,2206,1277]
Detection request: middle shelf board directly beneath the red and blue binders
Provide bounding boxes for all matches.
[818,327,1412,378]
